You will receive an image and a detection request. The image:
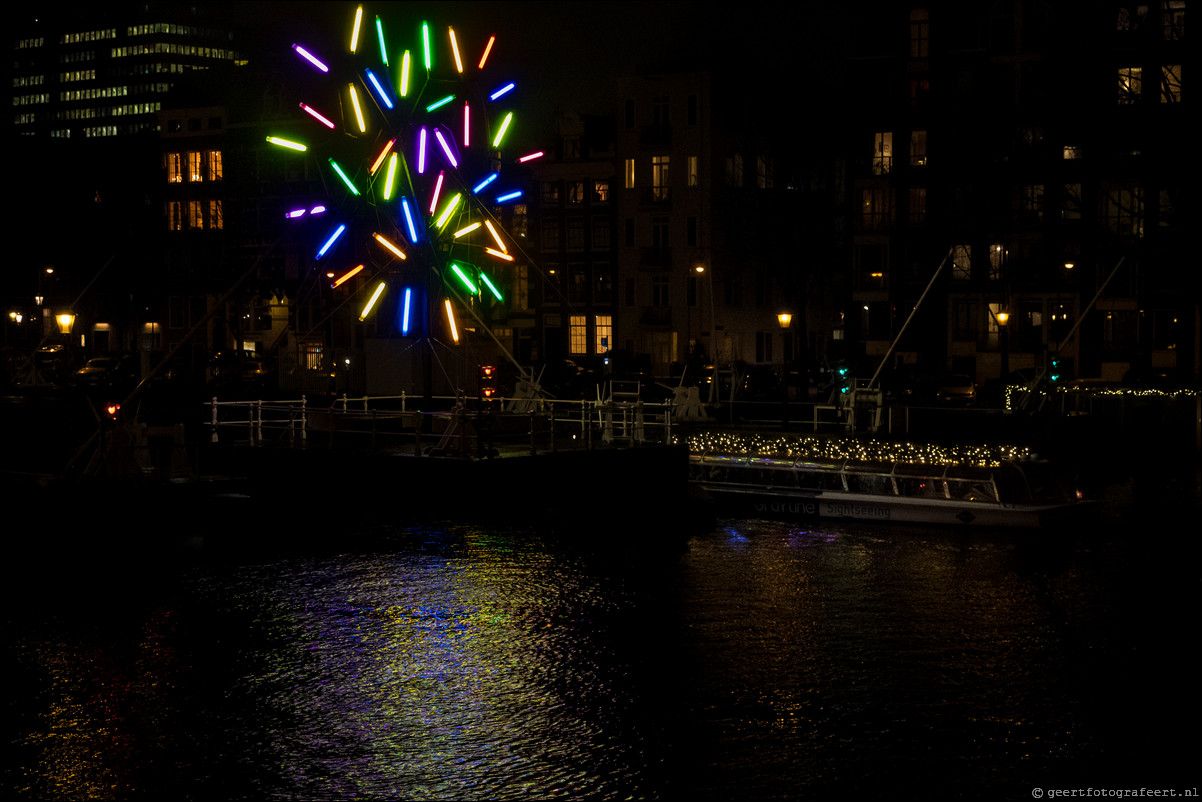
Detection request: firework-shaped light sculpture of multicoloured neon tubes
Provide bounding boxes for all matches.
[267,5,542,343]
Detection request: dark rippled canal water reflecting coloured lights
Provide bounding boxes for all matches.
[0,487,1202,800]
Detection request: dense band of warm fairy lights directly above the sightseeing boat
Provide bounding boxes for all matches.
[684,430,1033,468]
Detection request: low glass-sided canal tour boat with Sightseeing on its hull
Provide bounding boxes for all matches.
[689,452,1083,527]
